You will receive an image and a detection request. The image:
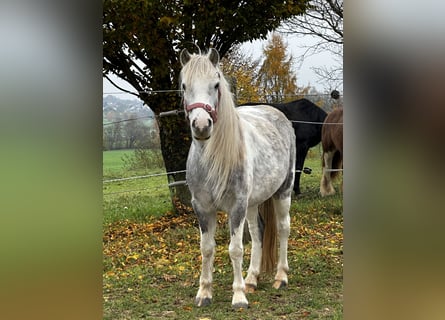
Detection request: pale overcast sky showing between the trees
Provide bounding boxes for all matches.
[103,36,343,99]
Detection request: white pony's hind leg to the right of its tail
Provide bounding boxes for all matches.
[273,196,291,289]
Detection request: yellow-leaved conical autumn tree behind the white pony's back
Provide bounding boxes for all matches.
[258,32,309,103]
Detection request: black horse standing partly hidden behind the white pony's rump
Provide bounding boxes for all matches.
[239,99,328,195]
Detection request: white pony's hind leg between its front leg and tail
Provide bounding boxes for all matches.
[245,206,263,293]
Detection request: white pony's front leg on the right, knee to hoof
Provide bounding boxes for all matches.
[229,205,249,309]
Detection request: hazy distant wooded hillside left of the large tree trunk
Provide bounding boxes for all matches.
[102,95,154,123]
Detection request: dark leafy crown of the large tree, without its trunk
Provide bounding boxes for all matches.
[103,0,308,85]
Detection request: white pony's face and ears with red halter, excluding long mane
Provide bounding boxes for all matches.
[180,48,222,140]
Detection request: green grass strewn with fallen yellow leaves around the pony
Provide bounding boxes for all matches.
[103,147,343,320]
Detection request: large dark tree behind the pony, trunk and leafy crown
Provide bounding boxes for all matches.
[103,0,308,208]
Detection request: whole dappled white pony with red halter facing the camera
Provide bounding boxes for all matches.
[180,49,296,308]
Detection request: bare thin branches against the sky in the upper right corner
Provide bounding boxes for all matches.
[279,0,343,90]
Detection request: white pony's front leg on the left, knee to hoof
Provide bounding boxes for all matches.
[193,204,216,307]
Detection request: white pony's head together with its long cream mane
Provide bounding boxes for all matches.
[180,49,241,203]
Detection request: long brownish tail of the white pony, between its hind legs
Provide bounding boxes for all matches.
[258,198,277,272]
